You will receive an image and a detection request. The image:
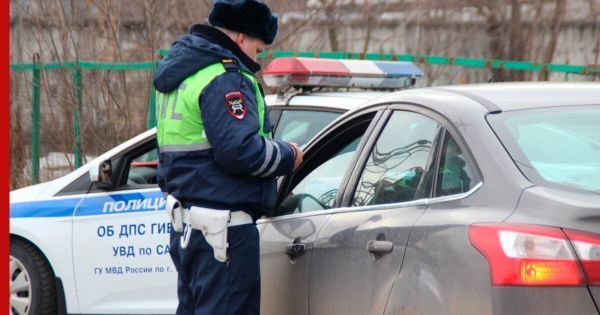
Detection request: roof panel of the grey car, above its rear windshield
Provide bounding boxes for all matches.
[435,82,600,111]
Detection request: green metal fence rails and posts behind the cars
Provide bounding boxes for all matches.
[10,50,600,184]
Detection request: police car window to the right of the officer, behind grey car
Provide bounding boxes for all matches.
[273,110,341,147]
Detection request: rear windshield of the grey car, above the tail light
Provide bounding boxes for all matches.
[488,106,600,192]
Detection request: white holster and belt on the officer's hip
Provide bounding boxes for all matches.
[167,195,252,262]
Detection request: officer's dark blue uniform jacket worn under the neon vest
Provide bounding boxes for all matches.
[154,25,295,219]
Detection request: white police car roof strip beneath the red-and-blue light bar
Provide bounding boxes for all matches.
[265,91,390,111]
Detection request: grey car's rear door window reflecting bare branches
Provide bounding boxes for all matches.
[352,111,439,206]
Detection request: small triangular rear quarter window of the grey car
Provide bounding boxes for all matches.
[435,133,478,197]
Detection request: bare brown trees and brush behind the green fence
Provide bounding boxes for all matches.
[10,0,600,188]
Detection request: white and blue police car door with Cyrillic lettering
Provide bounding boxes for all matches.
[73,137,177,314]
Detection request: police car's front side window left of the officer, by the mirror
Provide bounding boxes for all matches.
[125,146,158,187]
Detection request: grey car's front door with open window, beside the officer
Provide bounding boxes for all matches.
[257,111,379,315]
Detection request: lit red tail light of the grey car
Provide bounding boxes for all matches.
[469,224,600,286]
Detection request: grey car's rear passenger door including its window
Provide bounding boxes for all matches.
[309,106,440,315]
